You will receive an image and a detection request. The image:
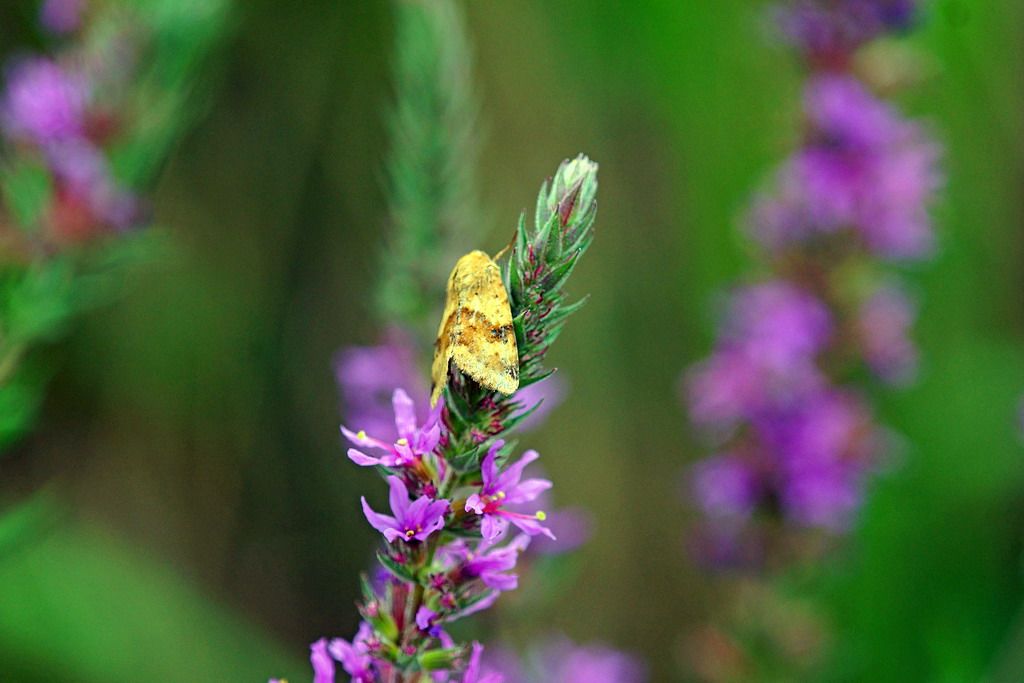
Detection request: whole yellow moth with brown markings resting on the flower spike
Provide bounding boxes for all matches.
[430,251,519,407]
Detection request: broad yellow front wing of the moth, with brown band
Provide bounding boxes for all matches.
[452,251,519,394]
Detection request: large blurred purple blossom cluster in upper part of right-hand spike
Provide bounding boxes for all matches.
[751,76,942,259]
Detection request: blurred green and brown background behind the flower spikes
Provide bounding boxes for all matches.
[0,0,1024,682]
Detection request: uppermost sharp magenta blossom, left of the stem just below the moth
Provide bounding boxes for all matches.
[341,389,443,467]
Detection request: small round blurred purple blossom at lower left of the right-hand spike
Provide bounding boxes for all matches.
[692,455,761,517]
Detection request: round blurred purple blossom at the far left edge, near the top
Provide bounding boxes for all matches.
[2,57,88,146]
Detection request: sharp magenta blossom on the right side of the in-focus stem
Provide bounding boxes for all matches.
[466,440,555,542]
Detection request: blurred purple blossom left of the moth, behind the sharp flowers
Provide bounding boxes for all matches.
[334,328,430,442]
